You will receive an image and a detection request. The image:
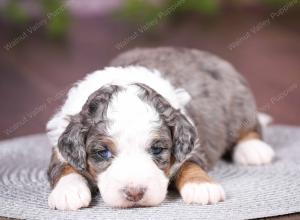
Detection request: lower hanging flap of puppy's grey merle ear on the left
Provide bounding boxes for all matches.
[58,115,88,170]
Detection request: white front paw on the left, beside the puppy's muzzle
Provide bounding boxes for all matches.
[48,173,91,210]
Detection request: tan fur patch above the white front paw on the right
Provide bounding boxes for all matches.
[175,162,213,191]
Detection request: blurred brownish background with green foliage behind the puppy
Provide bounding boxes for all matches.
[0,0,300,139]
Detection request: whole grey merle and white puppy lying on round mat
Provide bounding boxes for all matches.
[47,48,274,210]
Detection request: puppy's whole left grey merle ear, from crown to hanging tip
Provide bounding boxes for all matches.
[58,85,121,170]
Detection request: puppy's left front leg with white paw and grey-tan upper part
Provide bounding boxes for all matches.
[48,150,91,210]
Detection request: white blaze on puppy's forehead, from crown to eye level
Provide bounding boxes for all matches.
[107,85,161,150]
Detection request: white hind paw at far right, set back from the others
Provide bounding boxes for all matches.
[233,139,275,165]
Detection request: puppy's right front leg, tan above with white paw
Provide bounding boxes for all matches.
[176,162,225,205]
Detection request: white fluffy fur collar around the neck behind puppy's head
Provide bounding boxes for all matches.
[47,66,190,146]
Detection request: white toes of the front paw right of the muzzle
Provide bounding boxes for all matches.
[180,183,225,205]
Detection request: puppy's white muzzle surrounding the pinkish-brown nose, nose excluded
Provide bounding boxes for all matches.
[98,153,169,208]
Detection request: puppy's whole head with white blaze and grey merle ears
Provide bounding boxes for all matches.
[58,84,197,207]
